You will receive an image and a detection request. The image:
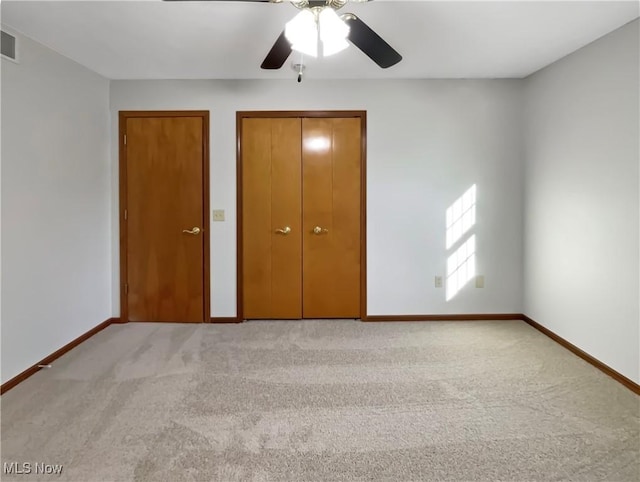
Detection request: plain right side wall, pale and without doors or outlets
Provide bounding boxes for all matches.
[524,20,640,382]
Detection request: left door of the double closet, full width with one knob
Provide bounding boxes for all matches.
[241,118,302,319]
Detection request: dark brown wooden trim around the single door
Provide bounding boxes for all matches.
[118,110,211,323]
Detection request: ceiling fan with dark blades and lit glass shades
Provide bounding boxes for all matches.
[164,0,402,70]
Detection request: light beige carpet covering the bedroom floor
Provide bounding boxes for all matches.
[2,320,640,482]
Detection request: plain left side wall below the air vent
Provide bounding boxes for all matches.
[1,30,111,382]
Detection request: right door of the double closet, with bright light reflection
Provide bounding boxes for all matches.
[302,117,362,318]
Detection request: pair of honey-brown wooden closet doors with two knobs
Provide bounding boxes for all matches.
[240,117,362,319]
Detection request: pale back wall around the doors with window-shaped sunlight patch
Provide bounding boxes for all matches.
[111,81,522,316]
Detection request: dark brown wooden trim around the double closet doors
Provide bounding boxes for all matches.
[236,110,367,322]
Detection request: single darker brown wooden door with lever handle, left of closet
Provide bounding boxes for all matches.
[121,115,208,322]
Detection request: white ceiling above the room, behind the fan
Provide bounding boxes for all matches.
[1,0,639,79]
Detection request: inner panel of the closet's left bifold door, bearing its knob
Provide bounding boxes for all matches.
[271,118,302,319]
